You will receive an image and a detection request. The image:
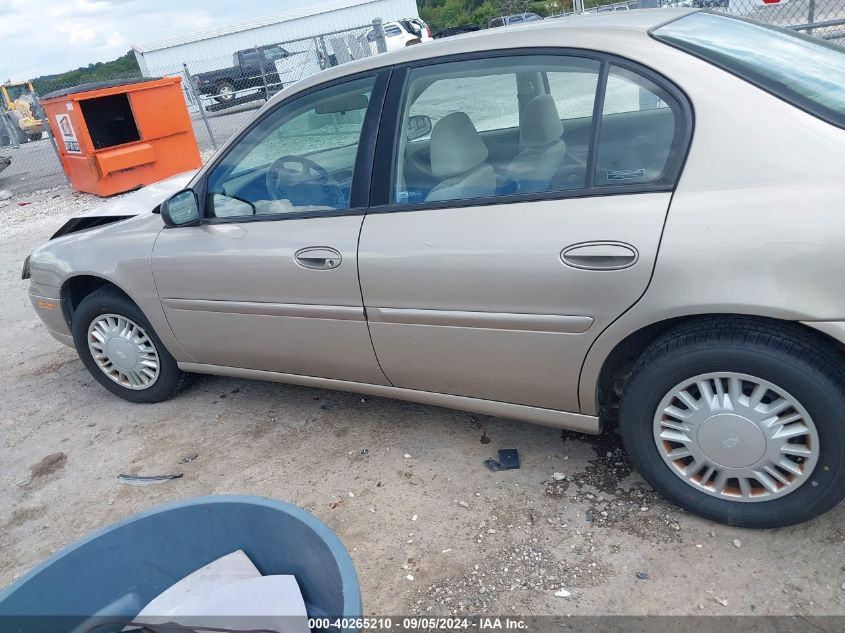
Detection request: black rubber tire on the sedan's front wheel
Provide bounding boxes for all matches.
[71,286,188,403]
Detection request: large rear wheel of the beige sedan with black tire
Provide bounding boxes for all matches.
[619,317,845,528]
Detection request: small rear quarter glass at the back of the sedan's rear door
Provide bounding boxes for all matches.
[595,66,680,187]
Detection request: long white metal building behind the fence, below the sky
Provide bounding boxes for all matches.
[132,0,419,77]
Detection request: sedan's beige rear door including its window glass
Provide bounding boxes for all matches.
[358,51,689,412]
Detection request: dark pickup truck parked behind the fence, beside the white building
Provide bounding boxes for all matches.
[194,44,290,103]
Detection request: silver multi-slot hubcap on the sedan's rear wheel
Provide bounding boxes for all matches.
[653,372,819,501]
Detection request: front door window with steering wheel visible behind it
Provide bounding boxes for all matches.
[206,77,375,218]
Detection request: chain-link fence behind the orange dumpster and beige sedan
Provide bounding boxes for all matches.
[0,6,845,194]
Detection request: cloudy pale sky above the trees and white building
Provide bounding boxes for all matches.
[0,0,321,82]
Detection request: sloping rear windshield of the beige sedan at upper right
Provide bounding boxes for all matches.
[653,13,845,127]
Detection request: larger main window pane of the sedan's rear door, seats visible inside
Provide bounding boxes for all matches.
[393,55,600,204]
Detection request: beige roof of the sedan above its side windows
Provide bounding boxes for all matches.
[262,8,699,109]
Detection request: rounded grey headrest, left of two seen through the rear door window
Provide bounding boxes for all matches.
[431,112,487,178]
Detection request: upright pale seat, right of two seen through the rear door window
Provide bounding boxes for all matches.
[505,94,566,192]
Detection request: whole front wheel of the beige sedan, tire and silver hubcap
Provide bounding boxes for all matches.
[72,287,187,402]
